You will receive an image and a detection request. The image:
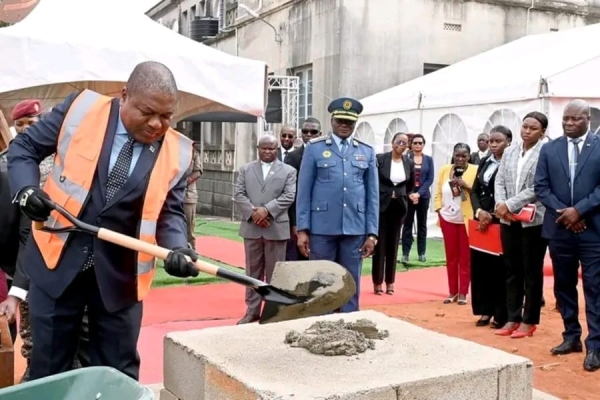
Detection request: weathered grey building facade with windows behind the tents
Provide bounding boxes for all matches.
[148,0,600,217]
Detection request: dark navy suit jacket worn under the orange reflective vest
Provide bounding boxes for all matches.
[8,94,188,312]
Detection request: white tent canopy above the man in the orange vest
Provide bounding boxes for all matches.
[0,0,267,119]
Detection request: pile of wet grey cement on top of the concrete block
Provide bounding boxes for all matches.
[285,319,389,356]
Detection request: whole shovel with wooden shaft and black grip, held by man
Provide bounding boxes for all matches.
[35,200,356,323]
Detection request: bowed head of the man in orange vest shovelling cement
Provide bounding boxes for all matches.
[121,61,177,144]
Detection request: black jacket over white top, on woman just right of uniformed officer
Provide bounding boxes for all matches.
[377,151,415,214]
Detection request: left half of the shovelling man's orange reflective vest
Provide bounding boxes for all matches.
[32,90,111,269]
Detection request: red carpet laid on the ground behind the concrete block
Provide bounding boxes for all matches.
[138,237,553,384]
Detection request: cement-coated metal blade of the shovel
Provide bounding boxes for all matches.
[259,261,356,324]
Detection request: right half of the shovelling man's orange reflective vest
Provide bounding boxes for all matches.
[137,129,193,300]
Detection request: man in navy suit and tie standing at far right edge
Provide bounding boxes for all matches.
[534,100,600,372]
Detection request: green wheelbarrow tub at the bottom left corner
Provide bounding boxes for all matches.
[0,367,154,400]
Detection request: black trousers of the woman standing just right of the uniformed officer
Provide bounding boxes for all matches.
[371,198,406,285]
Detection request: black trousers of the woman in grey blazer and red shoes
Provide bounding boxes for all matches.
[500,222,548,325]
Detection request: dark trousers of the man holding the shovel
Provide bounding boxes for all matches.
[29,267,142,380]
